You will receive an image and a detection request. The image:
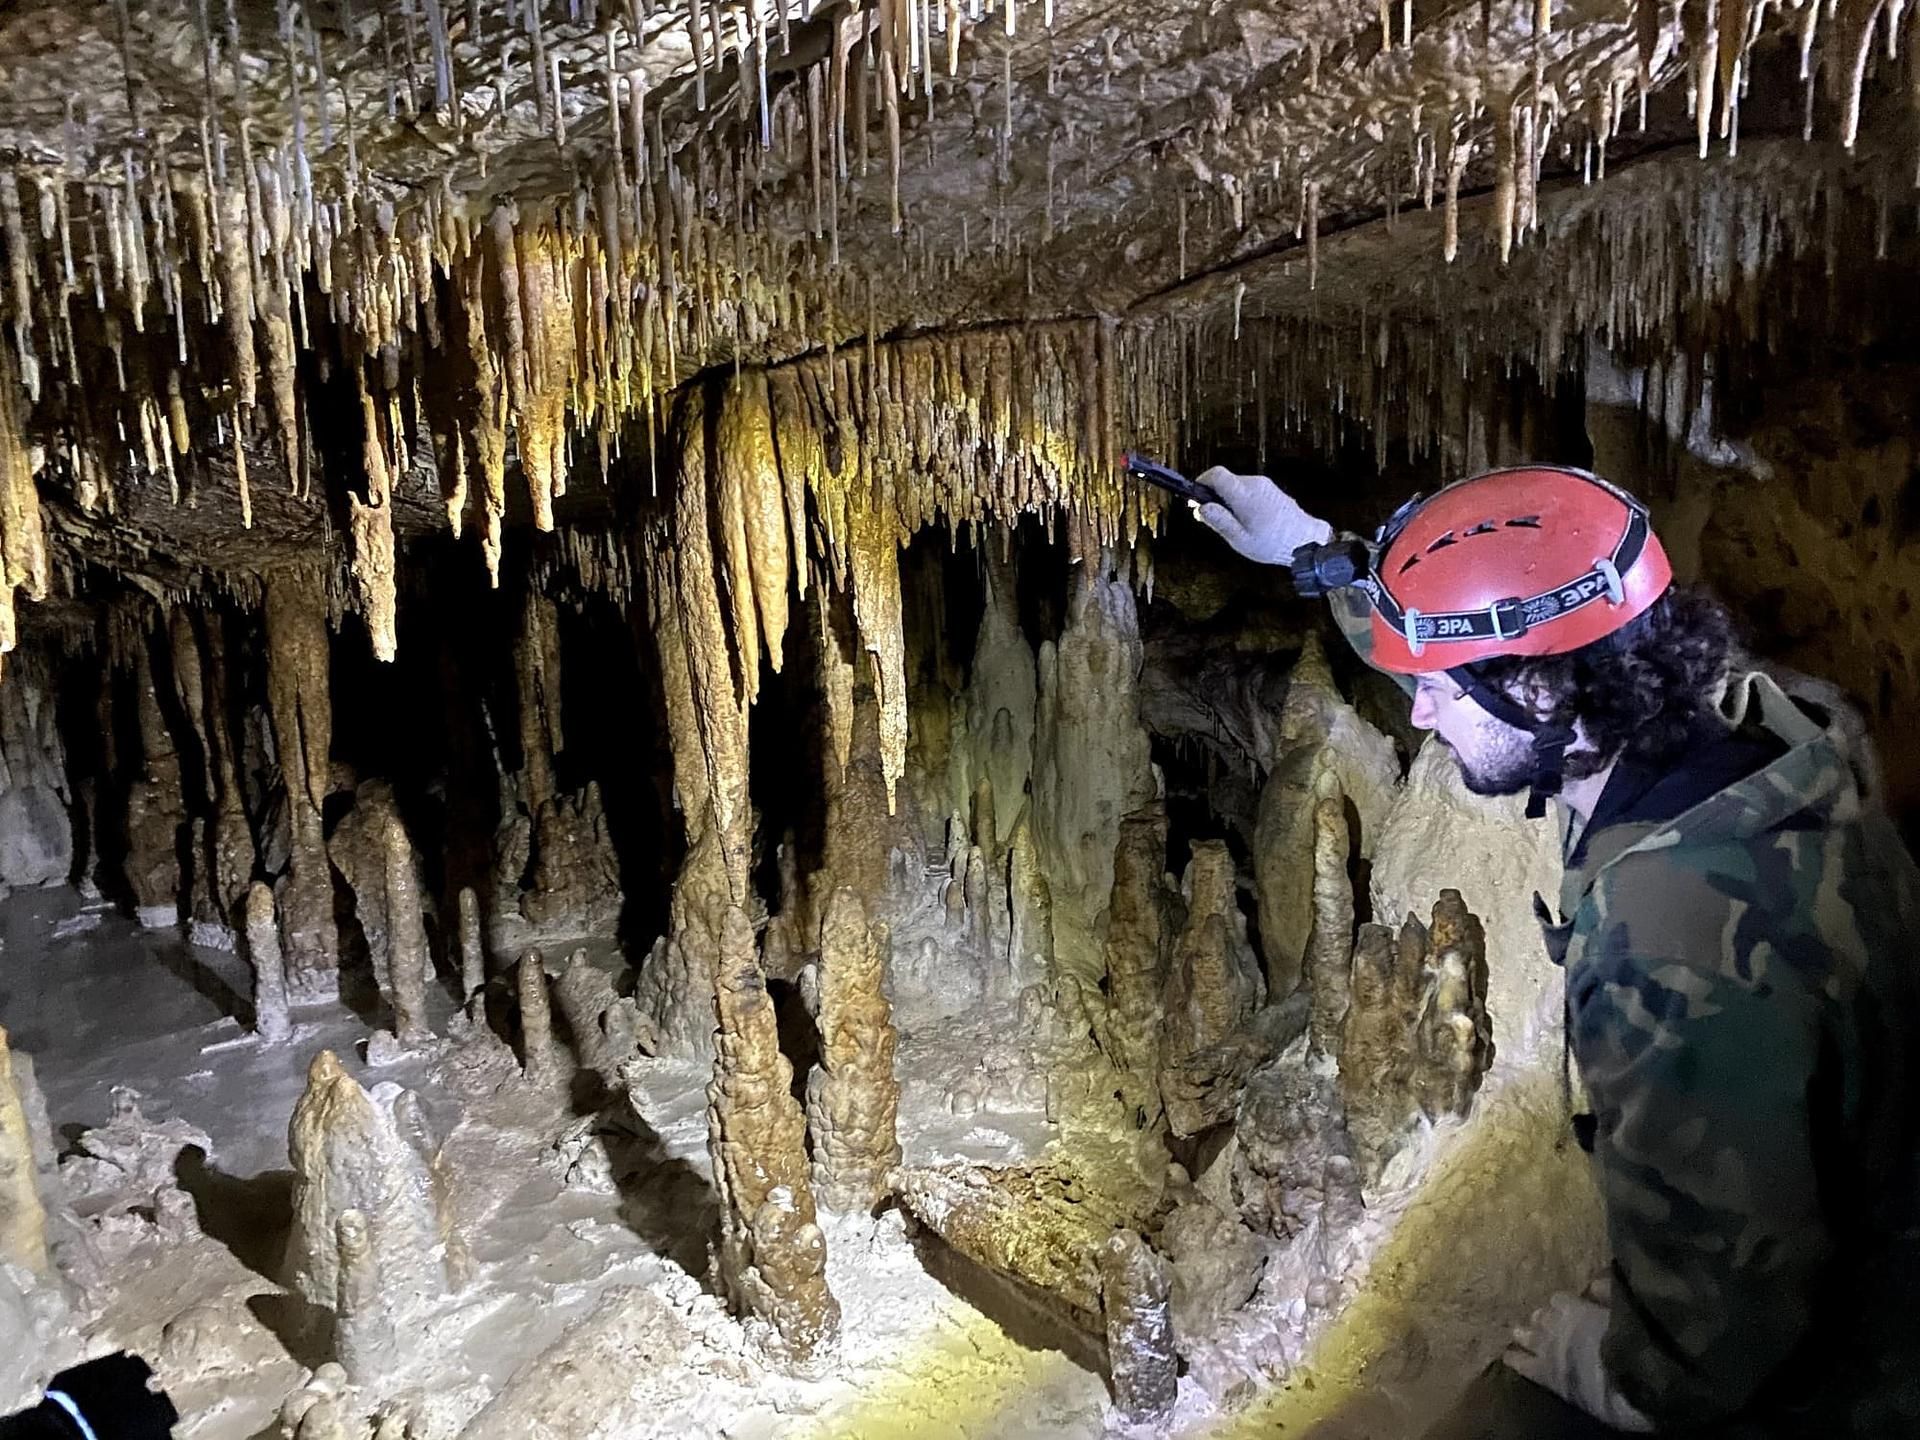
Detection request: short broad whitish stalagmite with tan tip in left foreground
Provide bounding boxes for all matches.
[286,1050,453,1332]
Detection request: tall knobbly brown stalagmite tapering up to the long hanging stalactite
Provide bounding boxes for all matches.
[707,906,839,1367]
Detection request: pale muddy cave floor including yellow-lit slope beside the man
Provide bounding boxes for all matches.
[0,889,1605,1440]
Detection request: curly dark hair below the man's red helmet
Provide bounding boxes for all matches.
[1475,586,1734,780]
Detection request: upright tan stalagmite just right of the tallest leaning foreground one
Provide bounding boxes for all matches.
[806,889,900,1210]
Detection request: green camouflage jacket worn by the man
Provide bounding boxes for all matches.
[1548,676,1920,1436]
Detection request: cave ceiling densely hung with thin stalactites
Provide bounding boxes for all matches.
[0,0,1920,622]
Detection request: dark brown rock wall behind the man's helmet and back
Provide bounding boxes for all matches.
[1588,348,1920,829]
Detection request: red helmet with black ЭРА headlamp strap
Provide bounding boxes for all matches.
[1365,465,1672,674]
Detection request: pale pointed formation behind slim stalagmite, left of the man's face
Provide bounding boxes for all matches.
[1254,636,1400,998]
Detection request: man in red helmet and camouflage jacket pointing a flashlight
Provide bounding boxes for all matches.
[1198,467,1920,1440]
